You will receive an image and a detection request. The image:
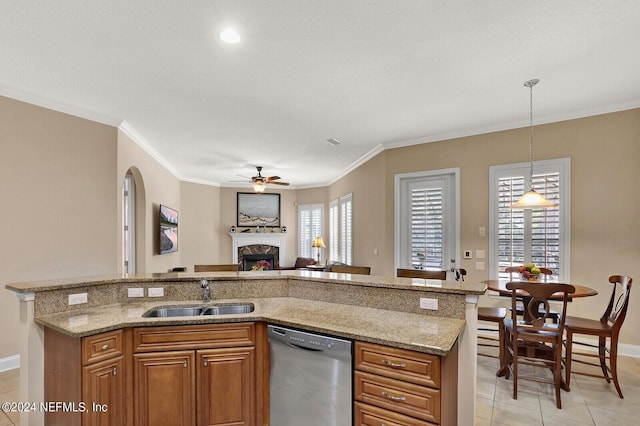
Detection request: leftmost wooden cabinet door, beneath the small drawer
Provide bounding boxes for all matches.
[82,357,125,426]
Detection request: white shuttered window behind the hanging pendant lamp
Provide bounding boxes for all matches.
[489,158,571,281]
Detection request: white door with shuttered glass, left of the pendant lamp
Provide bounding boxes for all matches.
[396,170,458,270]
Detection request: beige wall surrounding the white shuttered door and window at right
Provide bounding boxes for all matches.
[338,109,640,345]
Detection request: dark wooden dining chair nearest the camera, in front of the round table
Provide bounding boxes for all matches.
[503,282,575,408]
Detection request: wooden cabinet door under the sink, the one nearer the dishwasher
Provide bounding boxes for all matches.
[197,347,256,426]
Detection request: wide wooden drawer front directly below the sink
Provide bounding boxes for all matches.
[133,322,256,352]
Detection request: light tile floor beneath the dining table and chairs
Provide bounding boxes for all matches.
[476,348,640,426]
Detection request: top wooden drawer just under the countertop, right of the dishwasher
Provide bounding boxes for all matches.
[354,342,440,389]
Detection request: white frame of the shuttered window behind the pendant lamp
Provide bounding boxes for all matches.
[488,158,571,282]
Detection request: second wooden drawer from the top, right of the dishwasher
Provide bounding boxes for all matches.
[354,371,440,423]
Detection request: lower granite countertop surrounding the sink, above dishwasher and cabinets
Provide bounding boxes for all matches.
[35,297,465,355]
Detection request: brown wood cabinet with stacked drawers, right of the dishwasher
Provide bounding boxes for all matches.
[354,342,458,426]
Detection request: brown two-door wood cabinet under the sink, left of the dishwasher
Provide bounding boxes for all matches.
[133,323,264,426]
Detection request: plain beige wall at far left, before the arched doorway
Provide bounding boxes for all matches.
[0,97,118,359]
